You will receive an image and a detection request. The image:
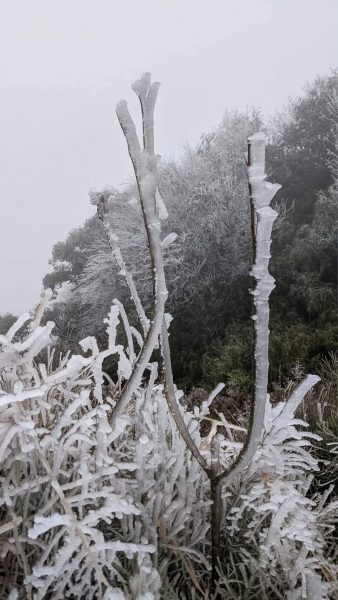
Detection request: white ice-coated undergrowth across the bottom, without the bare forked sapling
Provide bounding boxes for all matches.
[0,305,337,599]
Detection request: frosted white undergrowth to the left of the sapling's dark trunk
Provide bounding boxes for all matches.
[0,292,215,599]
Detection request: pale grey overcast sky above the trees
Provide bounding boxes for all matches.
[0,0,338,314]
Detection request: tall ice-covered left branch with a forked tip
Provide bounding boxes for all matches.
[116,73,208,472]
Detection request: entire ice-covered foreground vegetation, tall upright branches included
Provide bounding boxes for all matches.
[0,75,338,600]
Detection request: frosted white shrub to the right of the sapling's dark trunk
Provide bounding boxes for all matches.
[218,376,338,600]
